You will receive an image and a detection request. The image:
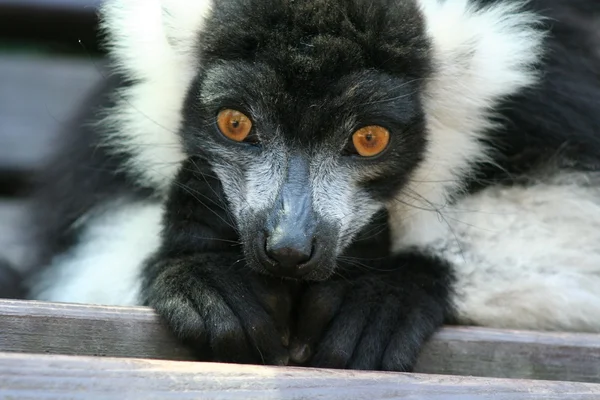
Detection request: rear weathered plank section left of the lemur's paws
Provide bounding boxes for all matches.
[0,300,193,360]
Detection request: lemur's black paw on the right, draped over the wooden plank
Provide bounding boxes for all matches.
[290,276,443,371]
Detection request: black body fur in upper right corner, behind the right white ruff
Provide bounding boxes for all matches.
[477,0,600,185]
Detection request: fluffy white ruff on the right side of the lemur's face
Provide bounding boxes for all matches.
[389,0,543,247]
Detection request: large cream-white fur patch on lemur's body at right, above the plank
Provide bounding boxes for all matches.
[397,174,600,332]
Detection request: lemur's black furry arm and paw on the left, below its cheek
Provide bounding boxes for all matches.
[142,158,291,364]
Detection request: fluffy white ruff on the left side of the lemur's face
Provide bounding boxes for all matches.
[101,0,212,194]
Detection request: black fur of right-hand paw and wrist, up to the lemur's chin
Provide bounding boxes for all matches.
[290,253,452,371]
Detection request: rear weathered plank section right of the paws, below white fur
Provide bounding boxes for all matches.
[416,327,600,382]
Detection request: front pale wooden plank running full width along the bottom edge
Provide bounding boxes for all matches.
[0,353,600,400]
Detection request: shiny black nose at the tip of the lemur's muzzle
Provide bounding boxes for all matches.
[265,236,313,277]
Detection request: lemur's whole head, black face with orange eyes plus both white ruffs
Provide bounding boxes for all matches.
[105,0,540,280]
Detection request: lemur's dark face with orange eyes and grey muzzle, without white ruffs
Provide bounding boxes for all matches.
[181,0,430,280]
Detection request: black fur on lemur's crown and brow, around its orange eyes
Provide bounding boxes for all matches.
[182,0,431,200]
